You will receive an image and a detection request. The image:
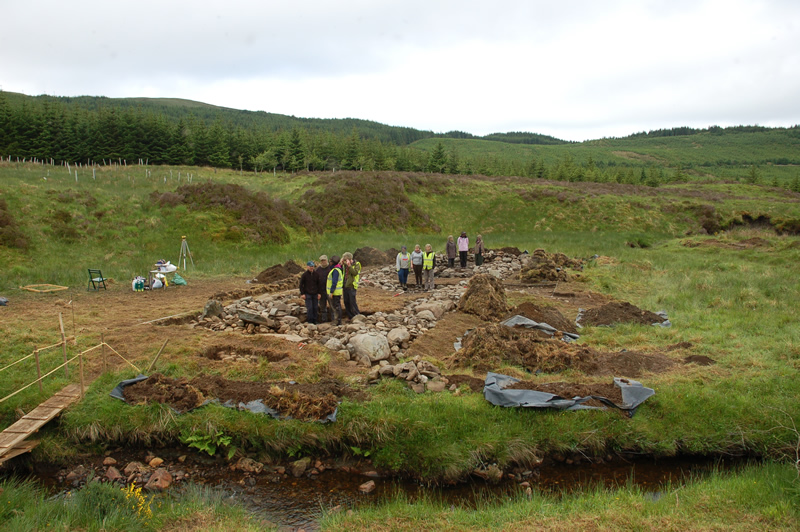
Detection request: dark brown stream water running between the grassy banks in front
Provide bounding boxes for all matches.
[6,450,745,530]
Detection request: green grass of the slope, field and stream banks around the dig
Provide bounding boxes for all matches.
[0,161,800,530]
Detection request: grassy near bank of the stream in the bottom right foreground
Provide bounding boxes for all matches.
[322,464,800,531]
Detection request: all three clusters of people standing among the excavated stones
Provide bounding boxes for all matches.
[300,231,486,325]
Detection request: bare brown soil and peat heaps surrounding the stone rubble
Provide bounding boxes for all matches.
[0,256,713,426]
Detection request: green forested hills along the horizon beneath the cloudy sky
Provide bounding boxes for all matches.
[0,91,800,189]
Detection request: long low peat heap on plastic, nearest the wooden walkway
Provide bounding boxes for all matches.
[124,373,361,420]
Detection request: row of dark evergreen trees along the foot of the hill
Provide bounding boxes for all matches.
[0,92,796,191]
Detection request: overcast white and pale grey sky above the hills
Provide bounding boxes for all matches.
[0,0,800,141]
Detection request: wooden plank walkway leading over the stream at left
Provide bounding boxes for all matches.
[0,384,81,464]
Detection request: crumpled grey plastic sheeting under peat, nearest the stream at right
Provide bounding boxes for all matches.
[483,372,656,417]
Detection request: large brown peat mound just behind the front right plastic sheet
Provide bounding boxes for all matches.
[448,325,675,377]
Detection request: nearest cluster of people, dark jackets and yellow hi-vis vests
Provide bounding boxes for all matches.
[300,252,361,325]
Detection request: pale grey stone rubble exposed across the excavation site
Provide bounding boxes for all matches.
[193,248,544,392]
